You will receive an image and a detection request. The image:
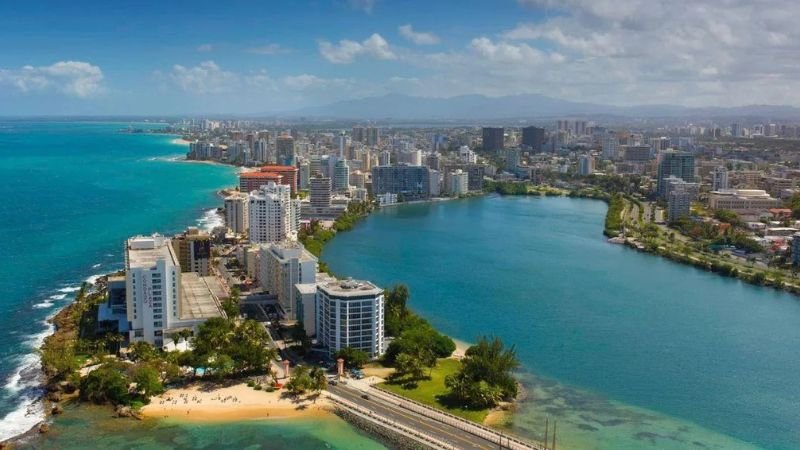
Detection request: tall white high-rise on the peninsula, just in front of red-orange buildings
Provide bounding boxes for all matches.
[248,182,300,244]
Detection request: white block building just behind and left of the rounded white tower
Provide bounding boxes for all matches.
[259,240,317,320]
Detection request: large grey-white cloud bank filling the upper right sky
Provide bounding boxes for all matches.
[394,0,800,106]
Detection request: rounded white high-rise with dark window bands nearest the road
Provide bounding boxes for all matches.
[316,279,384,358]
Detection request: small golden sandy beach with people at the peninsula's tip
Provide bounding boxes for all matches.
[141,383,331,421]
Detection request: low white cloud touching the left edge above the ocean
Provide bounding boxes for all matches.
[0,61,105,98]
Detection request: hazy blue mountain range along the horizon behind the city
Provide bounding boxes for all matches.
[281,94,800,121]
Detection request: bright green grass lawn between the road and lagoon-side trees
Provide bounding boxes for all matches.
[379,359,489,423]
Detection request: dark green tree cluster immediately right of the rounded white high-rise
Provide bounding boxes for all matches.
[383,284,456,385]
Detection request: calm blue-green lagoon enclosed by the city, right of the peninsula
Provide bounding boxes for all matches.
[323,197,800,450]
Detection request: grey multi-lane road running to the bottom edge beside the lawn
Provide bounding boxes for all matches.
[328,385,502,449]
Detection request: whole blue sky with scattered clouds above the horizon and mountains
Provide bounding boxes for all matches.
[0,0,800,115]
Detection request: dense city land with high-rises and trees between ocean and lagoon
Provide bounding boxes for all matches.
[31,119,800,448]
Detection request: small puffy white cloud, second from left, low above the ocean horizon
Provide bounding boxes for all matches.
[156,61,241,95]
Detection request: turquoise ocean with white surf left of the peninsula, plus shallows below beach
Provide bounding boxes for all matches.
[0,121,379,449]
